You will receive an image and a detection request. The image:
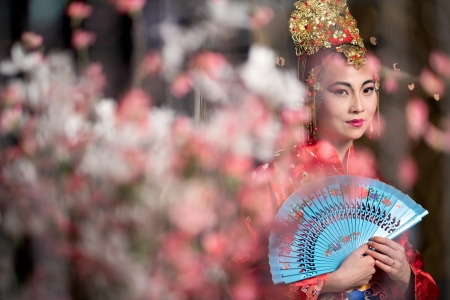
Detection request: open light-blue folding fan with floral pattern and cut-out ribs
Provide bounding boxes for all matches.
[269,175,428,284]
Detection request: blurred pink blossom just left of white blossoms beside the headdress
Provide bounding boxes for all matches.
[191,52,228,79]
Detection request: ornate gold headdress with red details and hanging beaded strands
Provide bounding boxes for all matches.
[289,0,380,143]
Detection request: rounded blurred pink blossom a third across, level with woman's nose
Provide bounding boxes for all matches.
[117,89,152,124]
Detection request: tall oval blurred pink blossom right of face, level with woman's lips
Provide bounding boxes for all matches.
[406,98,429,140]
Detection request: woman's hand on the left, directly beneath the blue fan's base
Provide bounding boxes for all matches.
[321,244,375,293]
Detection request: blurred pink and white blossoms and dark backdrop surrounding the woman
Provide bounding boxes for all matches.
[0,0,450,299]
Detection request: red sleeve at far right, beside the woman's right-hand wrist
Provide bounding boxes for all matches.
[398,231,439,300]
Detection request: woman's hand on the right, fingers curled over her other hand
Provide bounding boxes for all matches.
[367,237,411,292]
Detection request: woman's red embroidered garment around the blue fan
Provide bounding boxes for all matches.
[243,140,439,300]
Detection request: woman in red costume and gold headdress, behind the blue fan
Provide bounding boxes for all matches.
[241,0,439,299]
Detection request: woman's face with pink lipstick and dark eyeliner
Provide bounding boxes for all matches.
[317,54,377,142]
